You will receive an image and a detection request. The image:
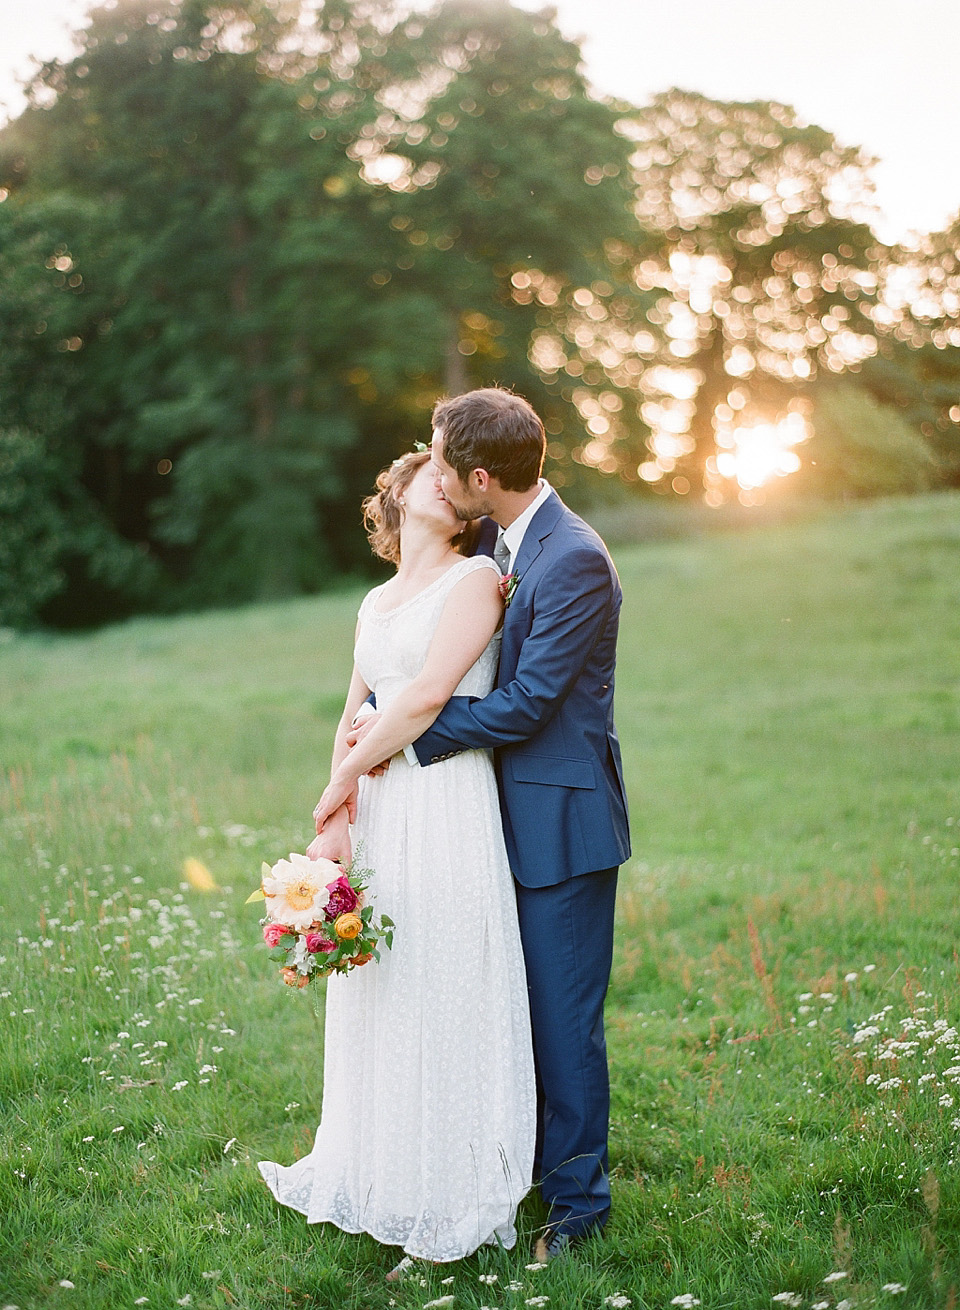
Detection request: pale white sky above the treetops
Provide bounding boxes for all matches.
[0,0,960,241]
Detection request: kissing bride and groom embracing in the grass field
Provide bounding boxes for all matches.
[259,388,630,1279]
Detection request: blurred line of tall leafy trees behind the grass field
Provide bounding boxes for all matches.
[0,0,960,626]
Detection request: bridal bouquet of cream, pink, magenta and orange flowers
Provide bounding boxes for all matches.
[246,852,394,988]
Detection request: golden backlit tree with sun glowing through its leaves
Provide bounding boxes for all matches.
[599,90,887,499]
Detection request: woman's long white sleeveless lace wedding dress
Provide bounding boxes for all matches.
[259,557,536,1260]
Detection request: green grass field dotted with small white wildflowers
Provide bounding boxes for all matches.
[0,495,960,1310]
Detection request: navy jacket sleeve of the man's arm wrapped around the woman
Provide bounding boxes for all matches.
[414,550,614,764]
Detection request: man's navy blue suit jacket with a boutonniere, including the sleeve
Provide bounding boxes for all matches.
[414,493,630,887]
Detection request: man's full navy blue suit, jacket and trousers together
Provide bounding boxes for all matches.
[414,493,630,1237]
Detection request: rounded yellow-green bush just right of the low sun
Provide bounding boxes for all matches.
[796,384,939,496]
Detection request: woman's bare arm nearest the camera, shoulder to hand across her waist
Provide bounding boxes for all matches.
[314,569,503,825]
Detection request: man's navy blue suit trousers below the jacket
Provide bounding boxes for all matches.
[516,869,618,1237]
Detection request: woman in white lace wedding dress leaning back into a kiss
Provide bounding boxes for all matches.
[259,453,536,1279]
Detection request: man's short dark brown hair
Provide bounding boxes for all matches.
[434,386,546,491]
